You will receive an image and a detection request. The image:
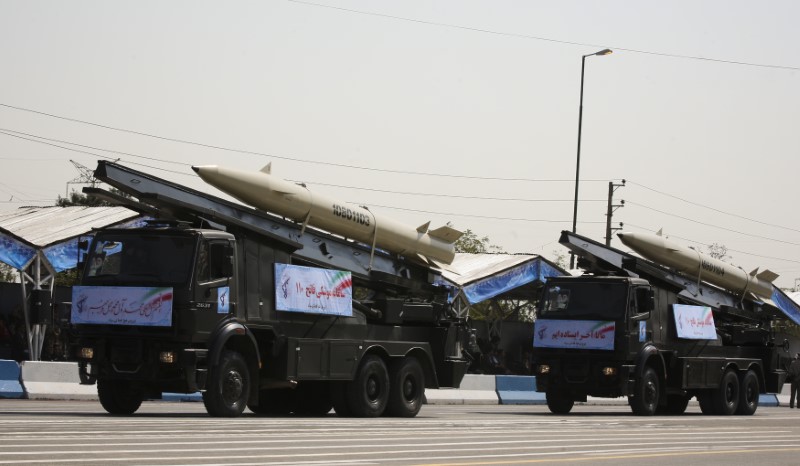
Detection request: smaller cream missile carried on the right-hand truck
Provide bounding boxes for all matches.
[617,233,778,299]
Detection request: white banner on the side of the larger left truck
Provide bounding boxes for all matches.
[275,264,353,317]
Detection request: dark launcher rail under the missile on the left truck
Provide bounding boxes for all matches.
[84,160,439,292]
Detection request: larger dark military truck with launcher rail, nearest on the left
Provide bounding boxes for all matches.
[70,161,469,417]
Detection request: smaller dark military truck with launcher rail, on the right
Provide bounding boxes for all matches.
[533,231,800,415]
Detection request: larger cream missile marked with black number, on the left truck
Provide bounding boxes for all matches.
[192,165,462,265]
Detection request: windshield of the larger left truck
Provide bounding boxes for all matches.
[84,234,195,286]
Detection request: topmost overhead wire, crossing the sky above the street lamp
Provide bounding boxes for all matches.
[288,0,800,71]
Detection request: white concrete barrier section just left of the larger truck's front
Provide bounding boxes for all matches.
[21,361,98,400]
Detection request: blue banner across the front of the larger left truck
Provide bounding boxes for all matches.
[71,286,172,327]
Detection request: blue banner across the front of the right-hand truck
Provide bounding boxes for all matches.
[533,319,616,351]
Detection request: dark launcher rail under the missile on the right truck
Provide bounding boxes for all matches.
[559,231,800,325]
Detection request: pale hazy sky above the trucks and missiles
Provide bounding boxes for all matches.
[0,0,800,287]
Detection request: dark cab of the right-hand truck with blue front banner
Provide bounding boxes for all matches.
[534,277,660,411]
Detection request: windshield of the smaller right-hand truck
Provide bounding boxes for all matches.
[539,282,628,319]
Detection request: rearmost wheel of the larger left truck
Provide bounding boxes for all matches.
[386,356,425,417]
